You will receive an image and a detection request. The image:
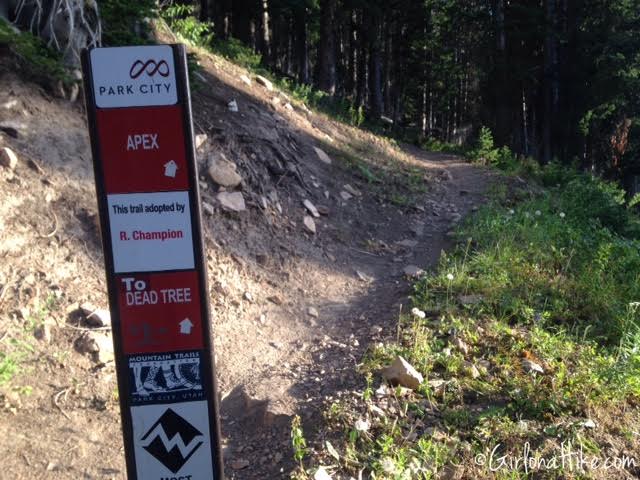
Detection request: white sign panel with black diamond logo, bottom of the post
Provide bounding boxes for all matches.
[131,401,215,480]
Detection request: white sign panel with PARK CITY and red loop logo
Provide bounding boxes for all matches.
[91,45,178,108]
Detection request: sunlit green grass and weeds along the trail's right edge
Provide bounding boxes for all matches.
[298,165,640,480]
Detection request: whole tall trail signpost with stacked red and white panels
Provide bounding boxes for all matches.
[82,45,223,480]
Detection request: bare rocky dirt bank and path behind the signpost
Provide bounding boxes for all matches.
[0,43,489,479]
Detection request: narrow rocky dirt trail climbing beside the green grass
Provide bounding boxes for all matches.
[222,146,489,479]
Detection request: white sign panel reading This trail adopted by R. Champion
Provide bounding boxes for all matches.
[107,192,194,273]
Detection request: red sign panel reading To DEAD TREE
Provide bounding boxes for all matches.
[116,271,203,354]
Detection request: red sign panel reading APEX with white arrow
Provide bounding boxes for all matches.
[96,105,189,193]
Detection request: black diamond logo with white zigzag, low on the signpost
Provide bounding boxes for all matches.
[141,408,204,473]
